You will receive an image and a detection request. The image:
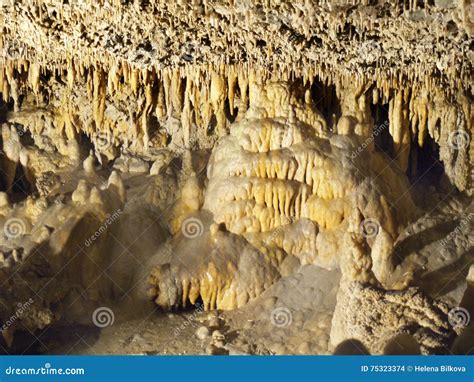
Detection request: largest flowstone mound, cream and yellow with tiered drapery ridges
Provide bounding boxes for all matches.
[204,80,416,283]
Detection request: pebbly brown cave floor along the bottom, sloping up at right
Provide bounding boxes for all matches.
[3,265,340,355]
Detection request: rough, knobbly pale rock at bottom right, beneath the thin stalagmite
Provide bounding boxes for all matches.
[330,283,454,354]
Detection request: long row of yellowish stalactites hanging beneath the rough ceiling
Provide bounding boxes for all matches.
[0,55,474,193]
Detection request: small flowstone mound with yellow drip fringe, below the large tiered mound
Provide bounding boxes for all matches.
[147,216,279,310]
